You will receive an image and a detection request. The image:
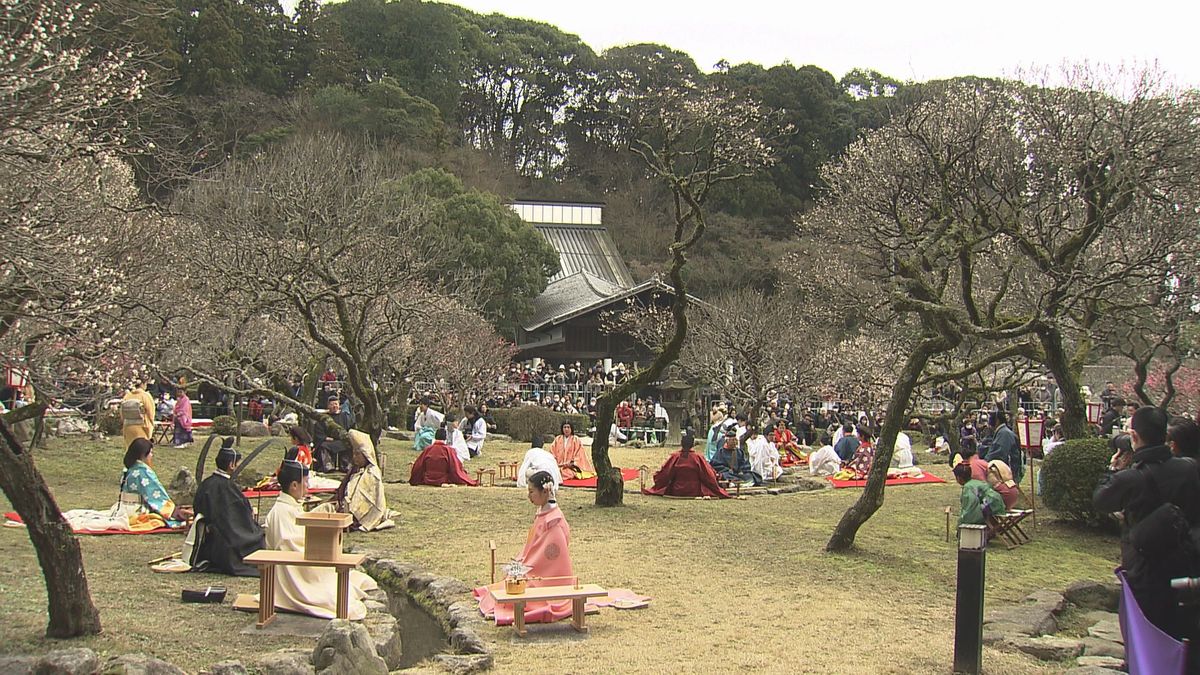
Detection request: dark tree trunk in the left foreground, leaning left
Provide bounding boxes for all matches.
[0,410,100,639]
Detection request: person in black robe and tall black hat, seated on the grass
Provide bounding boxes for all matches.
[188,437,266,577]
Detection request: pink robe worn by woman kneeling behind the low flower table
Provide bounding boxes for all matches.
[475,506,575,626]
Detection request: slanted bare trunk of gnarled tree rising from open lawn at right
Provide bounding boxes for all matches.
[826,342,935,552]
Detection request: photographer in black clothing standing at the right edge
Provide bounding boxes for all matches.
[1092,406,1200,639]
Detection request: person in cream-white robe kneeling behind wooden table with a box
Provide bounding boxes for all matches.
[265,460,379,621]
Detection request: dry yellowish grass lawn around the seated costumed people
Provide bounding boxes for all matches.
[0,432,1118,674]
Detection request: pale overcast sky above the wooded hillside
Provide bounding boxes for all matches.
[439,0,1200,86]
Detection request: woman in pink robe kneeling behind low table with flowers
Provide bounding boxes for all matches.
[474,471,575,626]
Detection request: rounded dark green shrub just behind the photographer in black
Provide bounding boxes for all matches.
[1040,438,1112,524]
